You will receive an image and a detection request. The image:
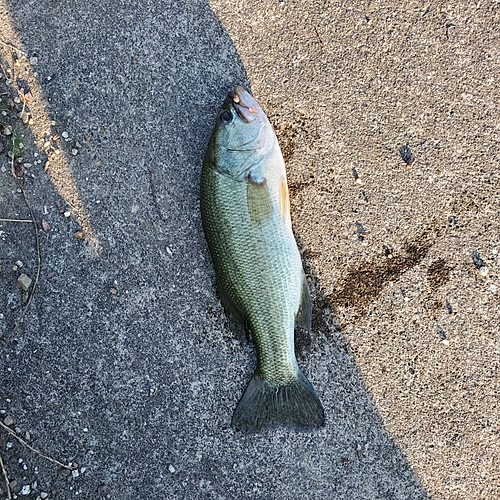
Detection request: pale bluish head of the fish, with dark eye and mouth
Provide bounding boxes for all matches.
[209,86,277,180]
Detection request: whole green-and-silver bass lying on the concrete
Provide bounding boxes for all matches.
[200,86,325,432]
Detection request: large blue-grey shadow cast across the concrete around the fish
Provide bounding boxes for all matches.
[0,0,427,500]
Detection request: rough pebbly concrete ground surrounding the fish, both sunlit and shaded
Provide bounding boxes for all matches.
[0,0,500,500]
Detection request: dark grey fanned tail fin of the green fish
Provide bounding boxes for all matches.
[232,370,325,432]
